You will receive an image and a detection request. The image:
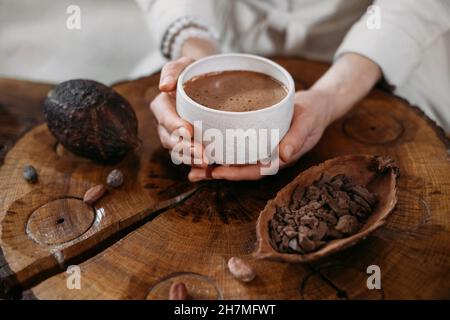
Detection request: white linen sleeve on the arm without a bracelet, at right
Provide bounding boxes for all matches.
[335,0,450,86]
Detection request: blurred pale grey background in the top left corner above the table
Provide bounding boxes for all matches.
[0,0,164,84]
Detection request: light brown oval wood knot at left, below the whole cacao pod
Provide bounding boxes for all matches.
[26,198,95,246]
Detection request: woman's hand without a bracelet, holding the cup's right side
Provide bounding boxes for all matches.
[189,53,381,181]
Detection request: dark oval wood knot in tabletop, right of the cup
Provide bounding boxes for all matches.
[342,111,405,145]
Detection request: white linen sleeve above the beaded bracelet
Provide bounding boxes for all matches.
[136,0,217,52]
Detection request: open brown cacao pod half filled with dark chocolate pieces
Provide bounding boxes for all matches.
[254,155,399,263]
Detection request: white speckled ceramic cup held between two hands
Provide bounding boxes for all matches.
[176,53,295,165]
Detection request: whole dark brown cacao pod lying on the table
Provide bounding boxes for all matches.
[44,79,140,162]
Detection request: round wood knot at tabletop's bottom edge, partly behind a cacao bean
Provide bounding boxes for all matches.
[146,272,222,300]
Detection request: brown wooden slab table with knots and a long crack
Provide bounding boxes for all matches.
[0,59,450,299]
